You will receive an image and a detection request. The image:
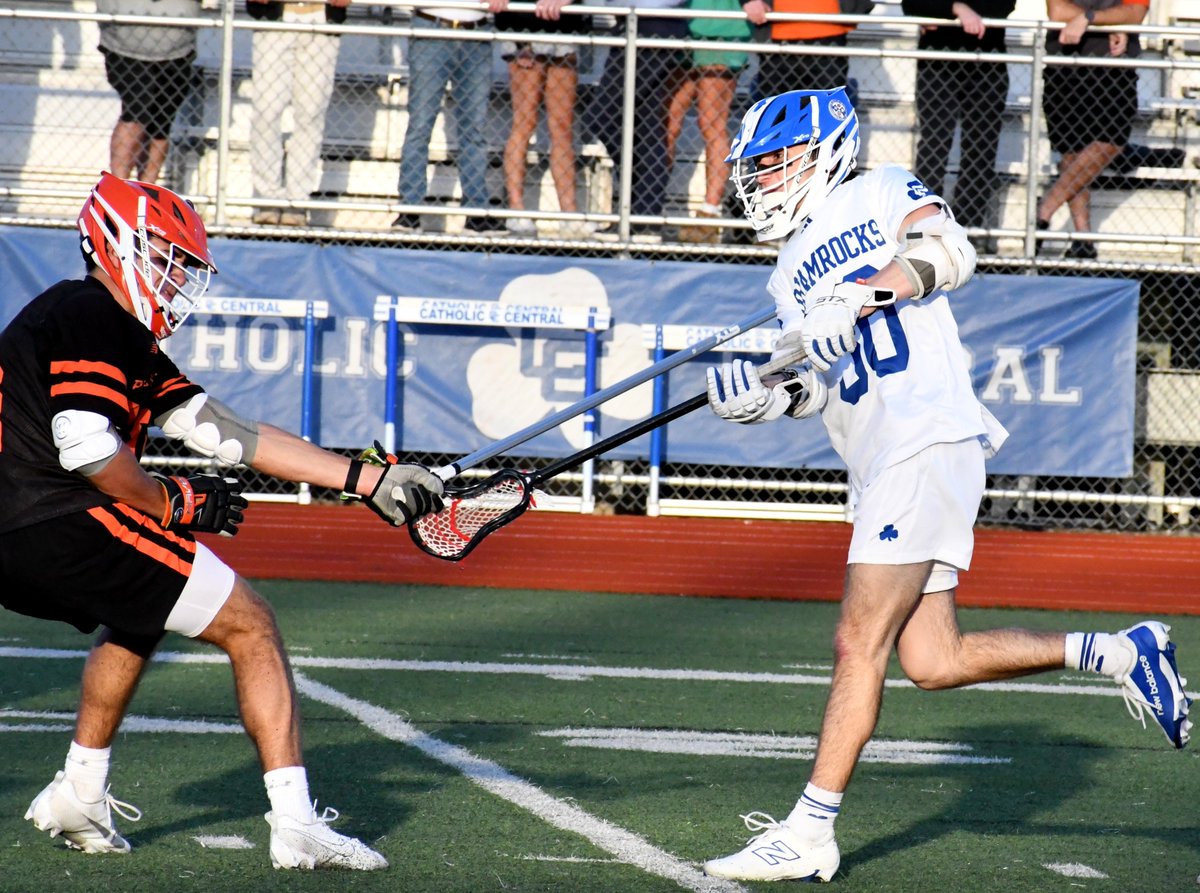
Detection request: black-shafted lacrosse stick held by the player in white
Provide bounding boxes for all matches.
[408,348,805,562]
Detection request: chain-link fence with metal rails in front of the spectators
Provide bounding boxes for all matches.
[0,0,1200,533]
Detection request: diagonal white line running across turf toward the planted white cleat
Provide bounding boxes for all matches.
[295,673,744,893]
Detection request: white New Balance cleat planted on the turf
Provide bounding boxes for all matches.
[704,813,841,882]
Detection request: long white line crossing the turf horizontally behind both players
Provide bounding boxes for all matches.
[0,646,1166,697]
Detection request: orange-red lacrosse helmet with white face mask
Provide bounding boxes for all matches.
[79,170,217,341]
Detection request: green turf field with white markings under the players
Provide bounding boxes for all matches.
[0,581,1200,893]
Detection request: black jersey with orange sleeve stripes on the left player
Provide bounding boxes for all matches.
[0,277,202,532]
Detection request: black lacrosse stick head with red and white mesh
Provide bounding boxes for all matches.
[408,469,534,562]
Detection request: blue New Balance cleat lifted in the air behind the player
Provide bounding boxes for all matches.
[1117,621,1192,748]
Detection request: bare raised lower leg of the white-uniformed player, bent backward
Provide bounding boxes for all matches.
[896,589,1066,691]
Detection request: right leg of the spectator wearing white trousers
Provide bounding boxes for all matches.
[287,34,338,200]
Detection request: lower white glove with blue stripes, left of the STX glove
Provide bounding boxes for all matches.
[707,360,826,425]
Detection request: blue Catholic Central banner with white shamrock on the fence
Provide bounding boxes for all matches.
[0,227,1139,477]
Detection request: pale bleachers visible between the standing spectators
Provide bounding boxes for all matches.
[0,0,1200,250]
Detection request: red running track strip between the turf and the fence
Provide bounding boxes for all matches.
[205,504,1200,615]
